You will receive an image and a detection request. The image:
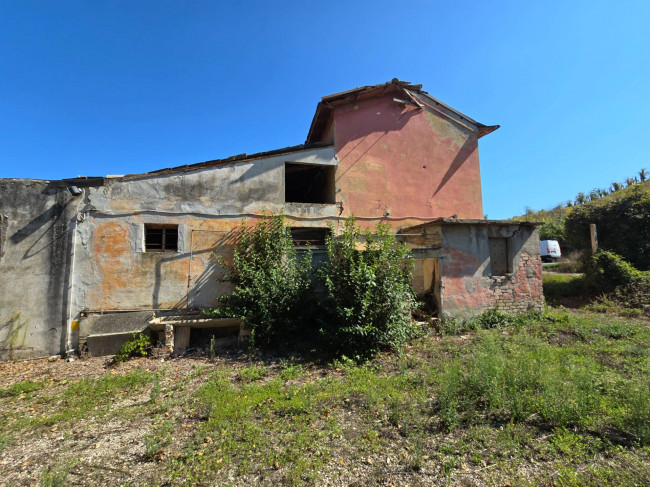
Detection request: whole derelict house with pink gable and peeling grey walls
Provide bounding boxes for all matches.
[0,80,543,359]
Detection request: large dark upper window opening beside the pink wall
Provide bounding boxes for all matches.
[284,162,335,203]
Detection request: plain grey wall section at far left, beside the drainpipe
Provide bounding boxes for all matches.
[0,179,79,360]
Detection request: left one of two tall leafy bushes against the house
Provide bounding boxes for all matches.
[212,214,311,346]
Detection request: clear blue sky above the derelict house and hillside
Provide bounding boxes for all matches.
[0,0,650,218]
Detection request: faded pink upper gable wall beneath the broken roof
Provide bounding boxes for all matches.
[334,97,483,233]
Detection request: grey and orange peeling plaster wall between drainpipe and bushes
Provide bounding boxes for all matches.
[73,147,338,320]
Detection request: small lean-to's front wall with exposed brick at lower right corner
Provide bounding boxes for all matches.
[440,225,544,318]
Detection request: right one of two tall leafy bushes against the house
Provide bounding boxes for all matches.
[319,218,417,360]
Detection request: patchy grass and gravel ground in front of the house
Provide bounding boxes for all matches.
[0,311,650,486]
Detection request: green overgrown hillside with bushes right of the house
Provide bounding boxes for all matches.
[515,170,650,316]
